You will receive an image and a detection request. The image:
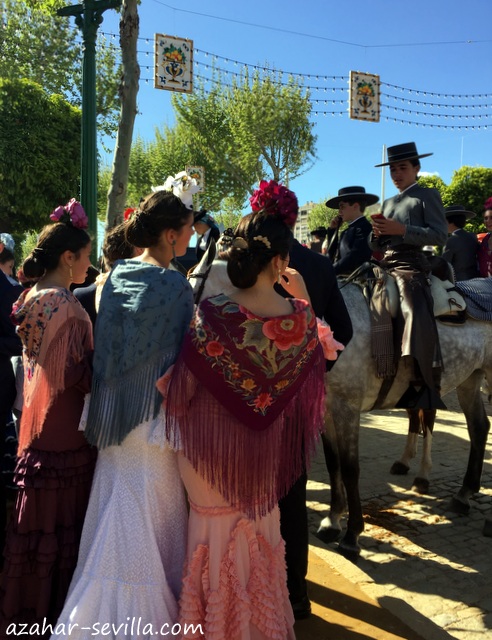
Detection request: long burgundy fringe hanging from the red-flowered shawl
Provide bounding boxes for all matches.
[165,348,325,518]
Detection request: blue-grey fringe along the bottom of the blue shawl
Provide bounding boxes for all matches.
[85,348,177,449]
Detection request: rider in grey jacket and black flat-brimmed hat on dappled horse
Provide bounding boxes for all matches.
[371,142,447,409]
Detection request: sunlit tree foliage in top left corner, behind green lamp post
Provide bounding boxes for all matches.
[0,0,119,135]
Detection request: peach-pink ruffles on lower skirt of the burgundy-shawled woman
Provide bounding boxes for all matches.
[180,518,294,640]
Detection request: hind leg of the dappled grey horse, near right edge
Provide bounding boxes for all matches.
[450,371,490,514]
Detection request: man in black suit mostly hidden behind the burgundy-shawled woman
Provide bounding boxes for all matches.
[279,240,352,619]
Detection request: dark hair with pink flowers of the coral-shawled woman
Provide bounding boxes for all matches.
[22,198,91,280]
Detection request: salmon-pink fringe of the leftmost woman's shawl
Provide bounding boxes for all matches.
[18,307,93,452]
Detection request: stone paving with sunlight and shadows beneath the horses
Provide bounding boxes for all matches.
[296,394,492,640]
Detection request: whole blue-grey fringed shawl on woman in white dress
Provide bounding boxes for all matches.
[85,260,193,448]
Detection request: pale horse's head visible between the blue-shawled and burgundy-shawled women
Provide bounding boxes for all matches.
[187,234,235,304]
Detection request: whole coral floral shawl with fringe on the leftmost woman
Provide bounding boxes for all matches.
[12,288,93,452]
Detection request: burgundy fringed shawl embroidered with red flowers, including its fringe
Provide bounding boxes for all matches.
[165,295,325,517]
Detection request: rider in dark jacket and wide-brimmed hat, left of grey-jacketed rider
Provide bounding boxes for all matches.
[326,187,379,276]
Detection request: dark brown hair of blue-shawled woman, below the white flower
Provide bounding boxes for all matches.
[125,190,191,248]
